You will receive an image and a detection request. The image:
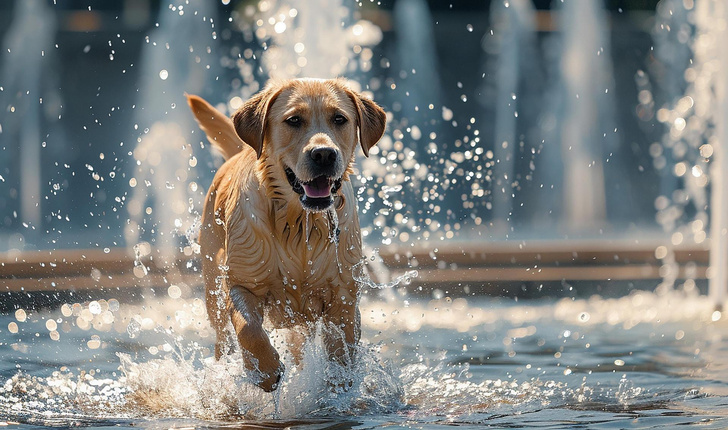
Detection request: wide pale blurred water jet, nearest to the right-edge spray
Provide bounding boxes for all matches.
[554,1,612,231]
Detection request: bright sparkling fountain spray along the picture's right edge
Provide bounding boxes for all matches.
[656,1,728,309]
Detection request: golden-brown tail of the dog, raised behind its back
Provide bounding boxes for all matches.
[186,94,245,160]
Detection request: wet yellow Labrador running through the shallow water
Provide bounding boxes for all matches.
[187,79,386,392]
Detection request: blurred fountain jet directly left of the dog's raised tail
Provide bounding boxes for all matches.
[125,0,219,270]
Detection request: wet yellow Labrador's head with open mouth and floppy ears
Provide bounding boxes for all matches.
[233,79,386,211]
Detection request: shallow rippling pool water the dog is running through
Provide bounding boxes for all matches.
[0,289,728,429]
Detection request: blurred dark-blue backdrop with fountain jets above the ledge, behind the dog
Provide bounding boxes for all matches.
[0,0,723,298]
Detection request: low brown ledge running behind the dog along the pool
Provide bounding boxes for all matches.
[0,240,709,292]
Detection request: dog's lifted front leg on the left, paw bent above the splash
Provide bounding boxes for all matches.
[229,286,283,392]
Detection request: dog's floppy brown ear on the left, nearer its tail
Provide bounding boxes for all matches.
[233,86,280,158]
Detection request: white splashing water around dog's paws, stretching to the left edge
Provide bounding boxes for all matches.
[0,324,403,425]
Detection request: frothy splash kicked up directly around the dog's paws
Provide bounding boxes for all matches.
[120,324,403,420]
